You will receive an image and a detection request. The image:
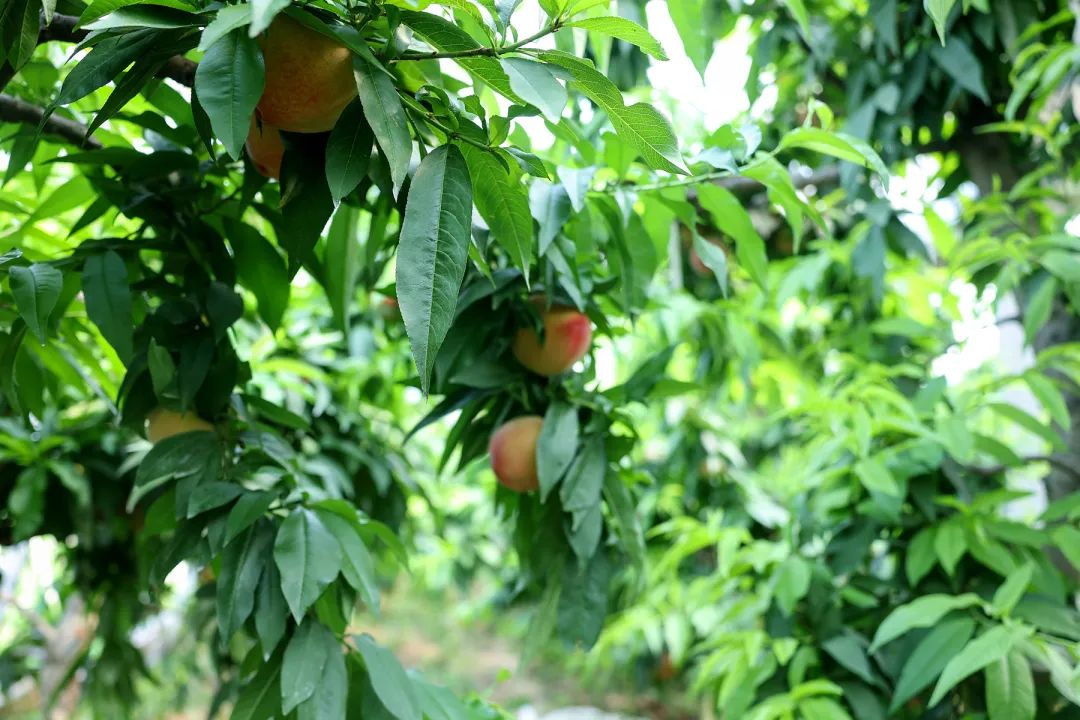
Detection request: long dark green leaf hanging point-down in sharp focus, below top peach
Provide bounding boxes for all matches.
[396,145,472,393]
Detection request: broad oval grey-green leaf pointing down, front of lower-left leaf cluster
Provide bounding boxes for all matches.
[273,508,341,622]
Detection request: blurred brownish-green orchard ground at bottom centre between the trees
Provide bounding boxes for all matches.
[355,582,698,720]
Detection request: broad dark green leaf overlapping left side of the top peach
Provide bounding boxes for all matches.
[194,28,266,159]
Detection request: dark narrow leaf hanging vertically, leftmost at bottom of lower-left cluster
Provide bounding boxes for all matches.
[217,525,273,646]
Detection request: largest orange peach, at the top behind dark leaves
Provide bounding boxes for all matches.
[258,15,356,133]
